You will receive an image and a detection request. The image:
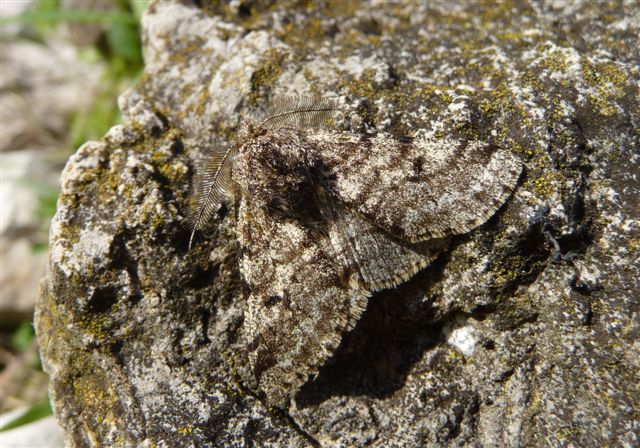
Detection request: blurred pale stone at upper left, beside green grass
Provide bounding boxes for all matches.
[0,37,104,151]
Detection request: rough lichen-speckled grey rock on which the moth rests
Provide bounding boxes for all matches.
[36,1,640,447]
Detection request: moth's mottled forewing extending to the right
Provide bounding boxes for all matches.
[308,131,522,242]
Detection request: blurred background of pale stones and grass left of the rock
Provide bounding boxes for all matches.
[0,0,148,448]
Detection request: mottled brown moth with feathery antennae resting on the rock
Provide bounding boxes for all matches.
[189,99,522,407]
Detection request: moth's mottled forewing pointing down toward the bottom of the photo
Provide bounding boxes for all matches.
[240,201,367,406]
